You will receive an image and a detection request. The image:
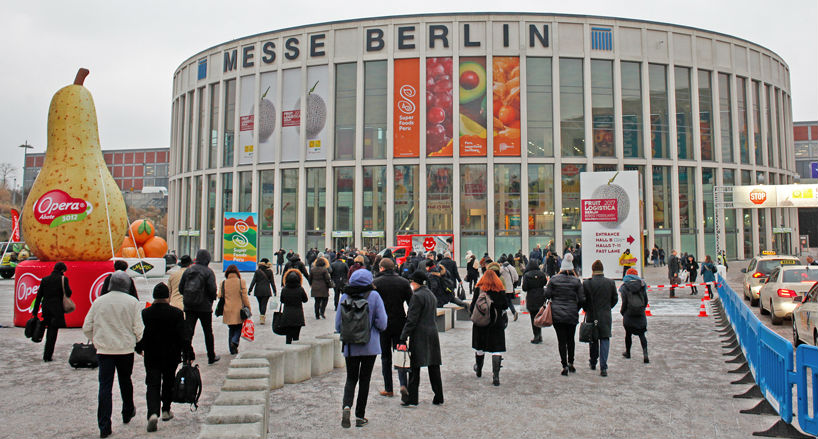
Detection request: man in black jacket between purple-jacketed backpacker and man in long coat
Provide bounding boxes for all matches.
[372,258,412,397]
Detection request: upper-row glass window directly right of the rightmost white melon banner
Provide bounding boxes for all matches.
[335,63,358,160]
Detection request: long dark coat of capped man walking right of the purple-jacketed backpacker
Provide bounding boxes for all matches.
[396,286,443,367]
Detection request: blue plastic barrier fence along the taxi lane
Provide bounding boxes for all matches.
[718,276,818,435]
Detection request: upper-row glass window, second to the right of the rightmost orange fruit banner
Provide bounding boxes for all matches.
[560,58,585,157]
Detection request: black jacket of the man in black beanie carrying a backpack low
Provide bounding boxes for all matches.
[135,303,193,369]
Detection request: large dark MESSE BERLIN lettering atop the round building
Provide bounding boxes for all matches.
[223,23,548,73]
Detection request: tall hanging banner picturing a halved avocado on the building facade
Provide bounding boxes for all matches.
[458,56,487,157]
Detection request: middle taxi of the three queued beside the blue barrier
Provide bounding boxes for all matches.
[758,265,818,325]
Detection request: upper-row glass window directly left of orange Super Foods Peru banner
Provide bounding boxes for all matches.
[364,60,387,159]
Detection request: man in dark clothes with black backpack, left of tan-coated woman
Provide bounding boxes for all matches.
[179,249,220,364]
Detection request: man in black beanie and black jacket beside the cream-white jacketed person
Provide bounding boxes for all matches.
[135,282,193,431]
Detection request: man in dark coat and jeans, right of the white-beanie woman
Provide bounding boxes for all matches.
[582,259,619,377]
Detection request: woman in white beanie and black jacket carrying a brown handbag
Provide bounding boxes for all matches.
[545,253,585,376]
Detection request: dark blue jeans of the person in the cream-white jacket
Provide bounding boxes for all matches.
[97,354,134,432]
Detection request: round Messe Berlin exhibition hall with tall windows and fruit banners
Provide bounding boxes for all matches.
[168,13,798,262]
